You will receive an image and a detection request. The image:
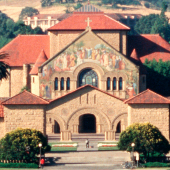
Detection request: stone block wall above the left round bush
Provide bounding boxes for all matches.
[4,105,45,134]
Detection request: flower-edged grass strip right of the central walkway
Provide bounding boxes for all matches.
[98,142,119,151]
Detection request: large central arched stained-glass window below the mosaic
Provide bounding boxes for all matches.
[79,69,98,87]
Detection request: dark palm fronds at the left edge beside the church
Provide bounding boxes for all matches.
[0,53,9,80]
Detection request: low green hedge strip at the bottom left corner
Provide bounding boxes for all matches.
[0,163,38,168]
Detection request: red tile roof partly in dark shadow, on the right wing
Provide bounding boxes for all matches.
[128,34,170,63]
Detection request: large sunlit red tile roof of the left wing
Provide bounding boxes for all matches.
[0,35,50,66]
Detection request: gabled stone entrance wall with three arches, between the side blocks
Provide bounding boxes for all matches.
[46,87,127,133]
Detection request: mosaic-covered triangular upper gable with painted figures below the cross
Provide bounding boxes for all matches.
[40,31,136,75]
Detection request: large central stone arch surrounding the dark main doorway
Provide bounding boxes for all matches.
[67,107,111,133]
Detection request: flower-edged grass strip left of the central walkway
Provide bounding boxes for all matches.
[49,142,77,152]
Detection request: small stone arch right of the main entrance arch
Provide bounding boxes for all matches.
[112,113,128,132]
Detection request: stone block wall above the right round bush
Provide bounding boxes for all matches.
[128,104,169,140]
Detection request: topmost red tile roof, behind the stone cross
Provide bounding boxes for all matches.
[48,12,130,31]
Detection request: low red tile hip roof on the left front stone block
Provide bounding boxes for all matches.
[2,90,49,105]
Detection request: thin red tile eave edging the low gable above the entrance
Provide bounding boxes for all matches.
[49,85,124,103]
